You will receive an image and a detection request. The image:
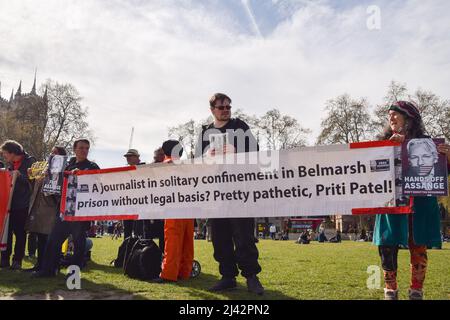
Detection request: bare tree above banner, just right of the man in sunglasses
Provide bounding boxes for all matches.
[255,109,310,150]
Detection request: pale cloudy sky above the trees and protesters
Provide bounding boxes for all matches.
[0,0,450,167]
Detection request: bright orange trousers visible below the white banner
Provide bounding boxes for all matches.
[160,219,194,281]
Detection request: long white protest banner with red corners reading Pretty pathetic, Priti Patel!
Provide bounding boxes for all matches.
[61,142,409,221]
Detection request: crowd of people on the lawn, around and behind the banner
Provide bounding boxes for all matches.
[0,93,450,299]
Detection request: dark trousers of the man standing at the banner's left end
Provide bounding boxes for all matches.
[41,217,89,274]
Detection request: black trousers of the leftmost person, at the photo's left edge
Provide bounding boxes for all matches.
[1,208,28,262]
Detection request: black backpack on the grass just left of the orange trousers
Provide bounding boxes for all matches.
[123,239,162,280]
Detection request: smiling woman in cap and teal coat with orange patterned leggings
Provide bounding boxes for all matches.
[373,101,450,300]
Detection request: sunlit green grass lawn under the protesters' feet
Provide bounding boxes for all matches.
[0,237,450,300]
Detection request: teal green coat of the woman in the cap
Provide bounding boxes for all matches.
[373,197,442,247]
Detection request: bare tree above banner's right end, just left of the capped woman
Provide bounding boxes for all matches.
[317,94,373,144]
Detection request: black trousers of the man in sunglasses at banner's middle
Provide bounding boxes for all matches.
[211,218,261,278]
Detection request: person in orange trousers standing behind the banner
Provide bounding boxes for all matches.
[154,140,194,283]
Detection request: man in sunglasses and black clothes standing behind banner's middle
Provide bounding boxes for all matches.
[195,93,264,295]
